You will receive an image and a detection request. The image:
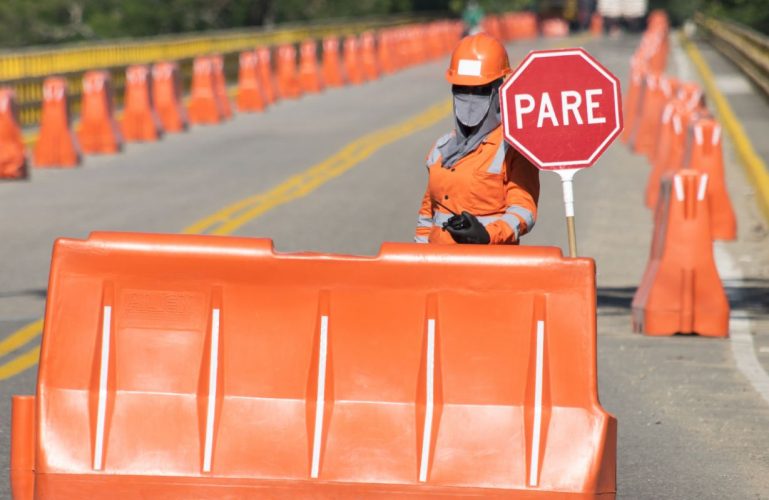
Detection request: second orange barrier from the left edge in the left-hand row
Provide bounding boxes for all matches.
[33,76,80,167]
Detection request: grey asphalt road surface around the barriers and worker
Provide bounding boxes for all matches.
[0,33,769,499]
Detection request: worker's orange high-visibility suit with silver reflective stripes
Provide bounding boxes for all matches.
[414,125,539,244]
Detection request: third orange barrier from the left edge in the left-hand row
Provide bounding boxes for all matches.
[77,71,123,154]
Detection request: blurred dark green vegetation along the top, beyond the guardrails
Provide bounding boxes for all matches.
[0,0,769,48]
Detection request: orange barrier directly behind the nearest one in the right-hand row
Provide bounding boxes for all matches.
[685,116,737,241]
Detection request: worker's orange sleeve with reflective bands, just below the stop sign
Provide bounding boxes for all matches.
[486,148,539,244]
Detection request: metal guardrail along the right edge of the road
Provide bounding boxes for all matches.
[694,14,769,95]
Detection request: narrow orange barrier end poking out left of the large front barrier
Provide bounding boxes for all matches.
[10,396,35,500]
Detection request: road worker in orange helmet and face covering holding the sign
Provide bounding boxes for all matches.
[415,33,539,244]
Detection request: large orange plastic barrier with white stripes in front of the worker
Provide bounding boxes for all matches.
[14,233,616,499]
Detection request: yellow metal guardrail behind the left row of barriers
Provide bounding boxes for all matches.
[0,16,429,127]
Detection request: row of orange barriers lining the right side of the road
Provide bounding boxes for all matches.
[622,11,737,337]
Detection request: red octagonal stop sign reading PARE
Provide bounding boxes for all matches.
[500,49,622,170]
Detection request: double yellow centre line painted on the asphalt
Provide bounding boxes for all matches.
[0,95,451,380]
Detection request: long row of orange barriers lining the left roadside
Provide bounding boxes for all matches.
[0,21,461,178]
